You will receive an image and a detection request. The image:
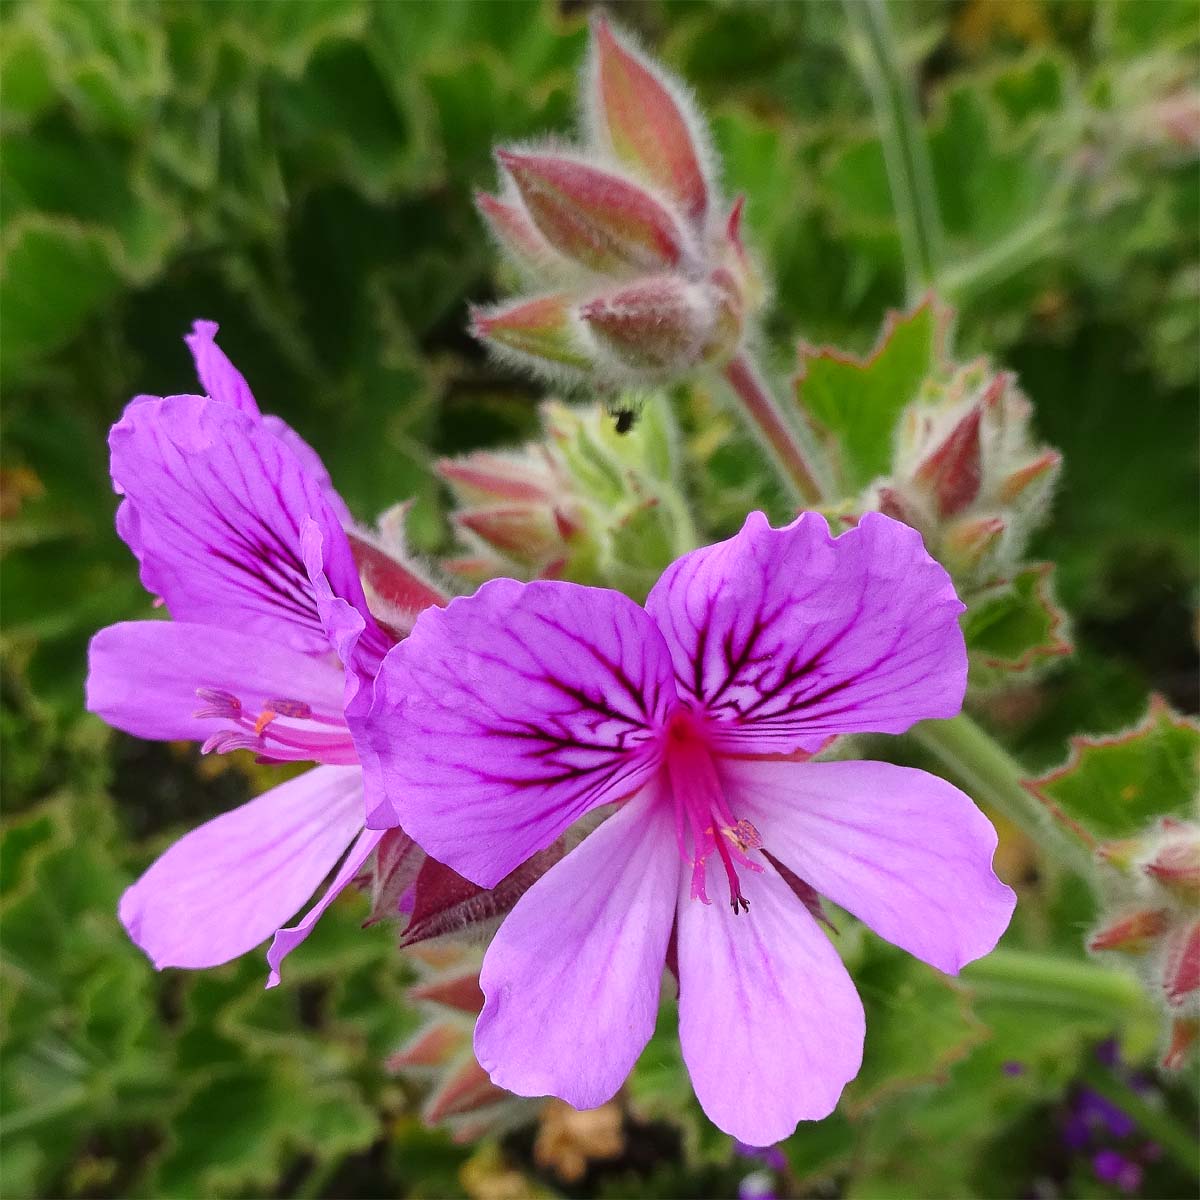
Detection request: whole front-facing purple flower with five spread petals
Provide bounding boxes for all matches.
[354,512,1014,1145]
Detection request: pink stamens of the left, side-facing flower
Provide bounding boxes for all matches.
[192,688,358,766]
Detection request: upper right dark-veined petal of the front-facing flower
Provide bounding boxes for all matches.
[646,512,967,754]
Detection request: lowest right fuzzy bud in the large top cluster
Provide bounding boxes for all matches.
[580,275,714,371]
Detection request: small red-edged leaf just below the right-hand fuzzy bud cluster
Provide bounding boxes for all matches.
[962,563,1073,689]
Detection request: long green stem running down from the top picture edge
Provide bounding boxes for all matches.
[844,0,943,299]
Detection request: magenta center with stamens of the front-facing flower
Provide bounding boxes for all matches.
[664,709,762,913]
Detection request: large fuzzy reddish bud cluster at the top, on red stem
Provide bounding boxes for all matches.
[473,18,761,384]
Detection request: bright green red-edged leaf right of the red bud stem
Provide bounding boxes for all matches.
[796,299,948,496]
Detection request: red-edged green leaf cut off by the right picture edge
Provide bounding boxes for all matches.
[1028,696,1200,841]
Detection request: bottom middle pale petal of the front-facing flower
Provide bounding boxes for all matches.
[677,865,865,1146]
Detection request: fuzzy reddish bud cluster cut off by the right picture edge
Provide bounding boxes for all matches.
[1088,818,1200,1069]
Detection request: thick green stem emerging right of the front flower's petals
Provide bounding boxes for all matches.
[912,713,1092,878]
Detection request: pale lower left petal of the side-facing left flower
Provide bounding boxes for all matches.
[119,767,362,970]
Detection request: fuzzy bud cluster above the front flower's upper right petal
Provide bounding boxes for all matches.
[866,362,1062,583]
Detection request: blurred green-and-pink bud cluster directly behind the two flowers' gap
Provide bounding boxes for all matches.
[437,396,691,594]
